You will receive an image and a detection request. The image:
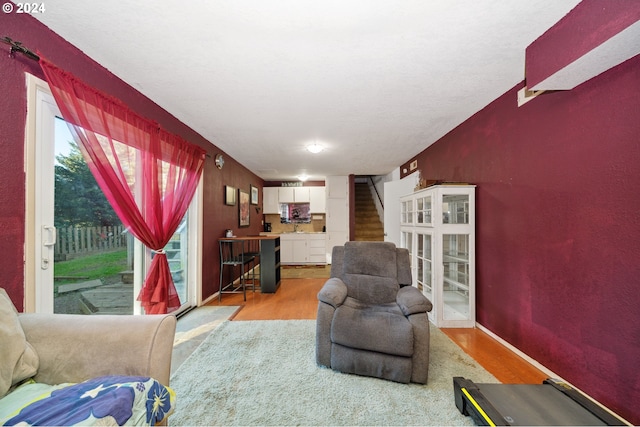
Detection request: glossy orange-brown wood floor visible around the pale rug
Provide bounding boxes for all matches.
[208,271,547,384]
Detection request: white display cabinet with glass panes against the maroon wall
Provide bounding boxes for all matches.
[400,185,476,328]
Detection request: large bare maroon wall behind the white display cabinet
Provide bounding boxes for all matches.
[401,56,640,424]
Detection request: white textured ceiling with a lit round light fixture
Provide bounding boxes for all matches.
[32,0,579,180]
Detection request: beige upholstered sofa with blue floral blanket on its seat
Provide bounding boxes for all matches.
[0,288,176,425]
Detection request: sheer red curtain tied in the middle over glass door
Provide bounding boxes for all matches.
[40,55,205,314]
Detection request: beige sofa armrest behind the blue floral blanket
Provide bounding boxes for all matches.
[19,313,176,386]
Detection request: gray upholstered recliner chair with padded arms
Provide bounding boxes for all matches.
[316,242,432,384]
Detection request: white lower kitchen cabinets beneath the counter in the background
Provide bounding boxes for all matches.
[280,233,327,264]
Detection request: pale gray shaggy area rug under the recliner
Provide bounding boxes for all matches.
[169,320,498,426]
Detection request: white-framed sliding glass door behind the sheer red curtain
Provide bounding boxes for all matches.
[25,76,201,314]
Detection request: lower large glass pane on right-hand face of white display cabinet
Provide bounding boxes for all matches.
[442,234,470,320]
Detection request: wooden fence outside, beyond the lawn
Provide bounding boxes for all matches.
[55,225,129,259]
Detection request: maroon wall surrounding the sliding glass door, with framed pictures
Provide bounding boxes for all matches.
[0,13,263,310]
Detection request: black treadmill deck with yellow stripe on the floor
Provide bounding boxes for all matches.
[453,377,627,426]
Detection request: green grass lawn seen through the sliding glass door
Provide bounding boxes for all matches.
[54,249,128,291]
